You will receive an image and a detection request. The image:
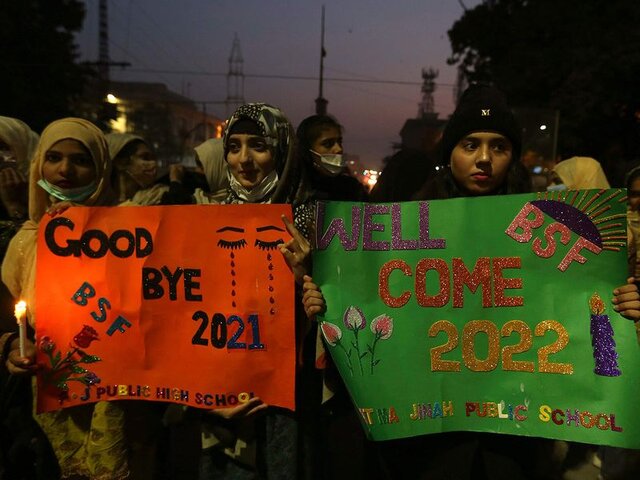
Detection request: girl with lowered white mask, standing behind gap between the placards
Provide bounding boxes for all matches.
[296,115,379,480]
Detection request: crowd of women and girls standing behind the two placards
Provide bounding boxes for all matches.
[0,85,640,480]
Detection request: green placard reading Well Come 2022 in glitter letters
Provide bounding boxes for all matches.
[314,190,640,448]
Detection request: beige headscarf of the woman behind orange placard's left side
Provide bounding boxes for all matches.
[2,118,113,324]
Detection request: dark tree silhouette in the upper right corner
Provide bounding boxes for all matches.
[448,0,640,173]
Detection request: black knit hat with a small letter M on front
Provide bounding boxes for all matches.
[442,84,522,164]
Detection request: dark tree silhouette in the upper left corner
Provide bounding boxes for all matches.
[0,0,92,131]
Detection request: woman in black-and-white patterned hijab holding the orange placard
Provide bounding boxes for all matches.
[194,103,320,480]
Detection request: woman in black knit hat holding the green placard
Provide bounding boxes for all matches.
[303,85,640,480]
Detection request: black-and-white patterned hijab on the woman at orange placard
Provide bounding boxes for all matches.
[222,103,300,203]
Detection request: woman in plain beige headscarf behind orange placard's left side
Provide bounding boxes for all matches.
[2,118,162,479]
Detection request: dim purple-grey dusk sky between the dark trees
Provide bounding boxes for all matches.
[78,0,481,167]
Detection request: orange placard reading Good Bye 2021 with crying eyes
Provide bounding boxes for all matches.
[36,205,295,411]
